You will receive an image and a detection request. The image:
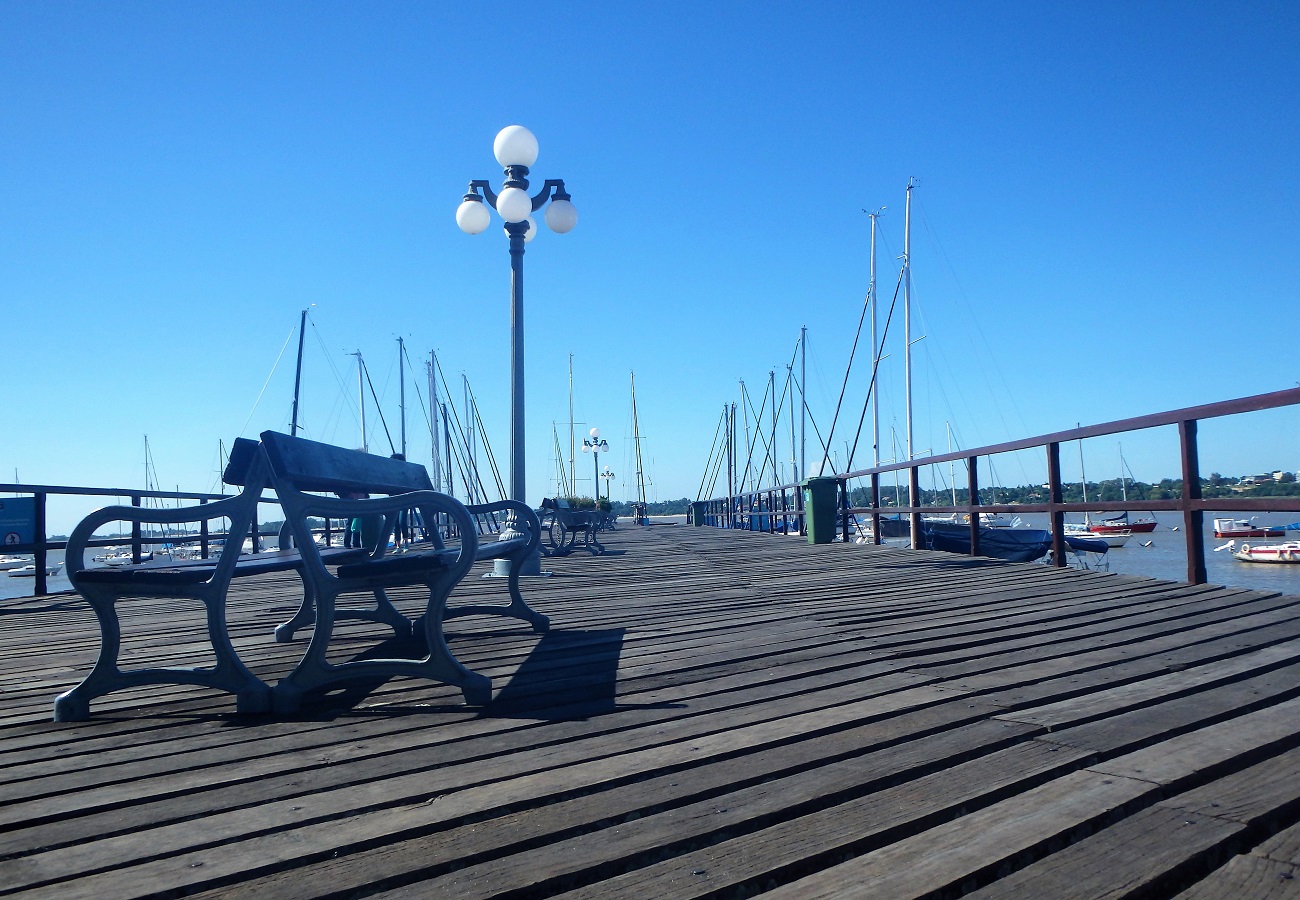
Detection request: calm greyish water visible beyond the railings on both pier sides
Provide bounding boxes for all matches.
[0,512,1300,600]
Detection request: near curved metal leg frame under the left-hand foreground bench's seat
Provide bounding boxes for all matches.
[55,589,270,722]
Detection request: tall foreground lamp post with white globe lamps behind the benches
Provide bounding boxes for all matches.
[456,125,577,574]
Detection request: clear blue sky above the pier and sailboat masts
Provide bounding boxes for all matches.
[0,3,1300,531]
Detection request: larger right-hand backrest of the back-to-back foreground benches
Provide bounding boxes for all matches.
[258,432,433,494]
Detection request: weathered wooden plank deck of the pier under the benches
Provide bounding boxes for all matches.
[0,527,1300,900]
